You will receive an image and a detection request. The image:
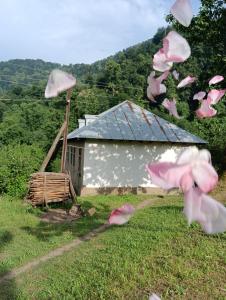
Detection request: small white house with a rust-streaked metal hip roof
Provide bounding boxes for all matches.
[67,101,206,195]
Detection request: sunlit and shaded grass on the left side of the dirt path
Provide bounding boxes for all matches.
[0,195,150,276]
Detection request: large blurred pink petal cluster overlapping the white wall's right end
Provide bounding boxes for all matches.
[147,147,218,193]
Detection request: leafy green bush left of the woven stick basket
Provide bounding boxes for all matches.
[0,145,44,197]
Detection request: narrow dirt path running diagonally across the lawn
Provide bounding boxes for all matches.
[0,200,153,284]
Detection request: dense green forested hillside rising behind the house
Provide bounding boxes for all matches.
[0,0,226,196]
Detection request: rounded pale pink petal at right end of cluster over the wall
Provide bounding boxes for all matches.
[192,160,218,193]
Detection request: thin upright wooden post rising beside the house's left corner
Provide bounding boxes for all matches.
[61,88,72,173]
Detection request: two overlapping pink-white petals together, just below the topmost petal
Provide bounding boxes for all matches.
[153,31,191,72]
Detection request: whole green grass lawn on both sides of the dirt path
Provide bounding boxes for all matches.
[0,196,226,300]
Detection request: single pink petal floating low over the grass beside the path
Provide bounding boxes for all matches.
[109,204,135,225]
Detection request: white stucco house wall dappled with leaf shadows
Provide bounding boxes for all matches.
[83,141,190,188]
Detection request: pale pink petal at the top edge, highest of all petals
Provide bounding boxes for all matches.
[170,0,193,27]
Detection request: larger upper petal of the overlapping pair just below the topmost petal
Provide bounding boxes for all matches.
[163,31,191,62]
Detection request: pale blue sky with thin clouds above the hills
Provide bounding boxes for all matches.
[0,0,200,64]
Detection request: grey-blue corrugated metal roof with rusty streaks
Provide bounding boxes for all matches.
[68,101,206,144]
